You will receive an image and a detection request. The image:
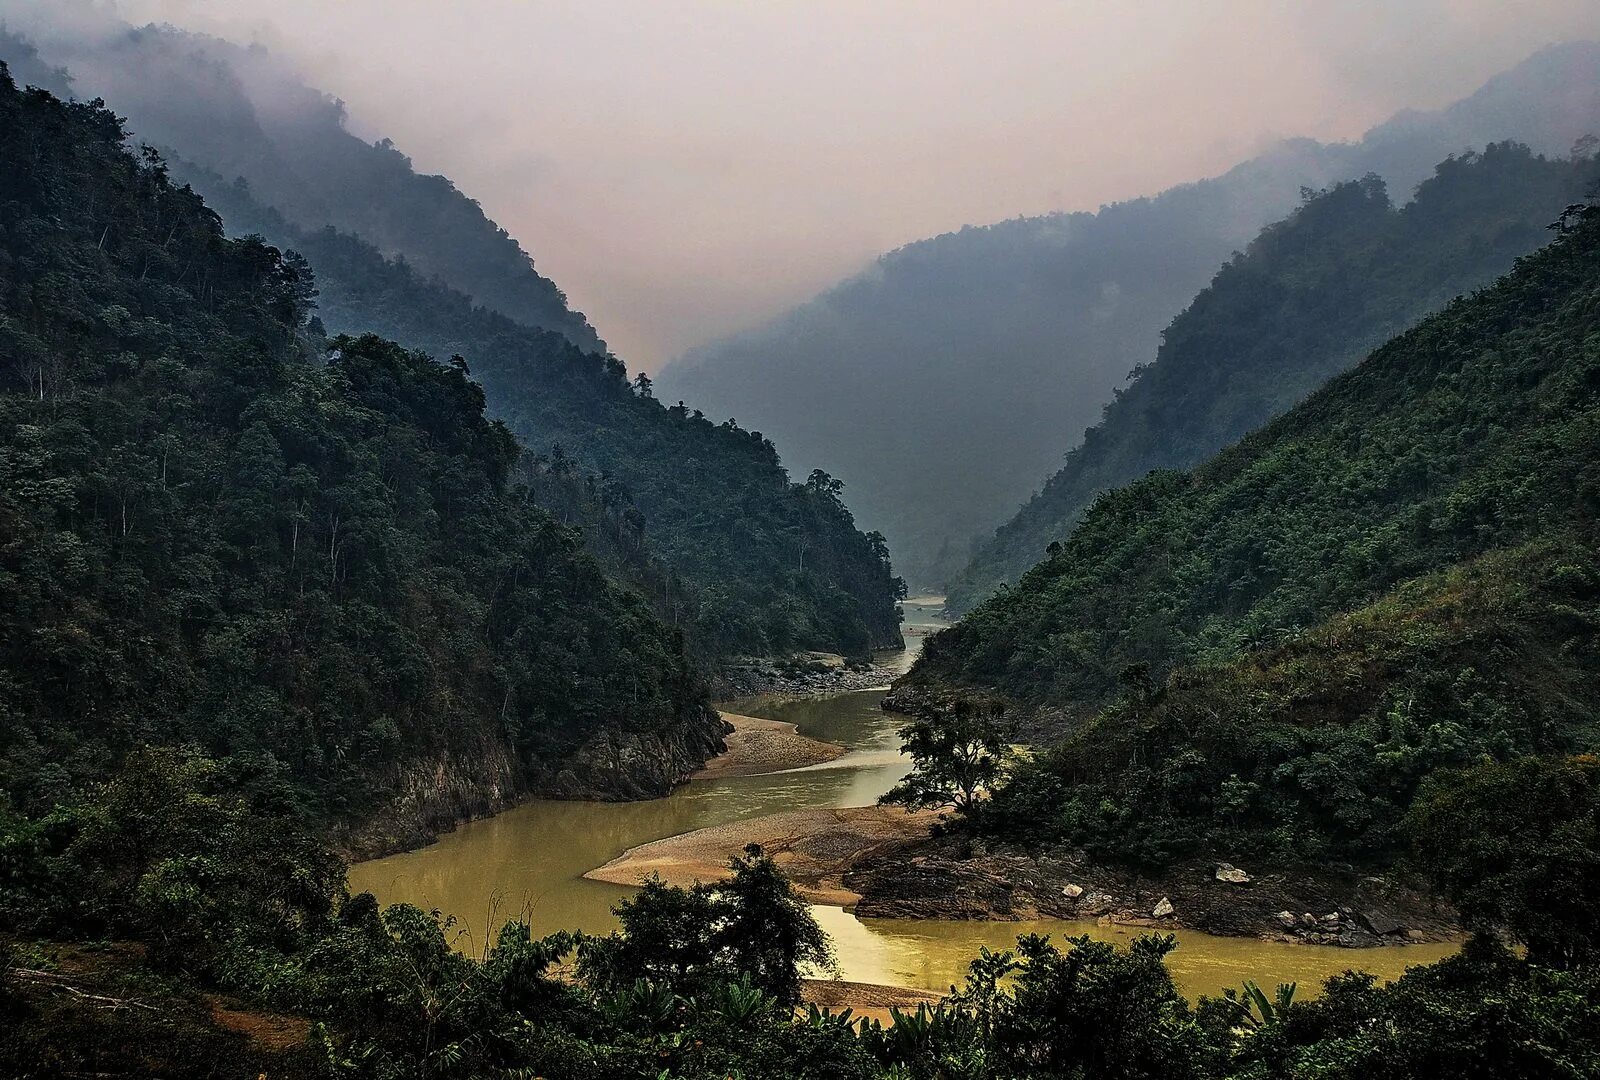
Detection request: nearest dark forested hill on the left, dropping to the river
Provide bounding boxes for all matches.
[0,75,720,851]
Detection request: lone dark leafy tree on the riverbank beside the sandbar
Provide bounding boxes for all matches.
[878,699,1008,814]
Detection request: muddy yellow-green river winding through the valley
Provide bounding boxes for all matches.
[350,602,1454,997]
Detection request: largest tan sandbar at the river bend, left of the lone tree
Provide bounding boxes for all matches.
[584,806,938,907]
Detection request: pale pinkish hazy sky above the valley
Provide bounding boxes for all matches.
[31,0,1600,370]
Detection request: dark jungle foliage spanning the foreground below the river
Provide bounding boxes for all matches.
[0,749,1600,1080]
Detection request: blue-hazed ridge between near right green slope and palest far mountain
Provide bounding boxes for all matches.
[949,144,1600,611]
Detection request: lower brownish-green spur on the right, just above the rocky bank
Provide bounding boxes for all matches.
[978,541,1600,864]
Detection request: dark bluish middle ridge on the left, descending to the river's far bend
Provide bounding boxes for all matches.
[181,168,901,656]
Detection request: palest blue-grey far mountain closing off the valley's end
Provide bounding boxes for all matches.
[658,45,1600,586]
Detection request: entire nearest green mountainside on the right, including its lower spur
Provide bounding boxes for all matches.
[891,192,1600,864]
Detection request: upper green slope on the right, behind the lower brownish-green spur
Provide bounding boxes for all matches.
[902,196,1600,717]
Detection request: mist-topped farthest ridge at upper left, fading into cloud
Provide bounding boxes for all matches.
[0,22,605,352]
